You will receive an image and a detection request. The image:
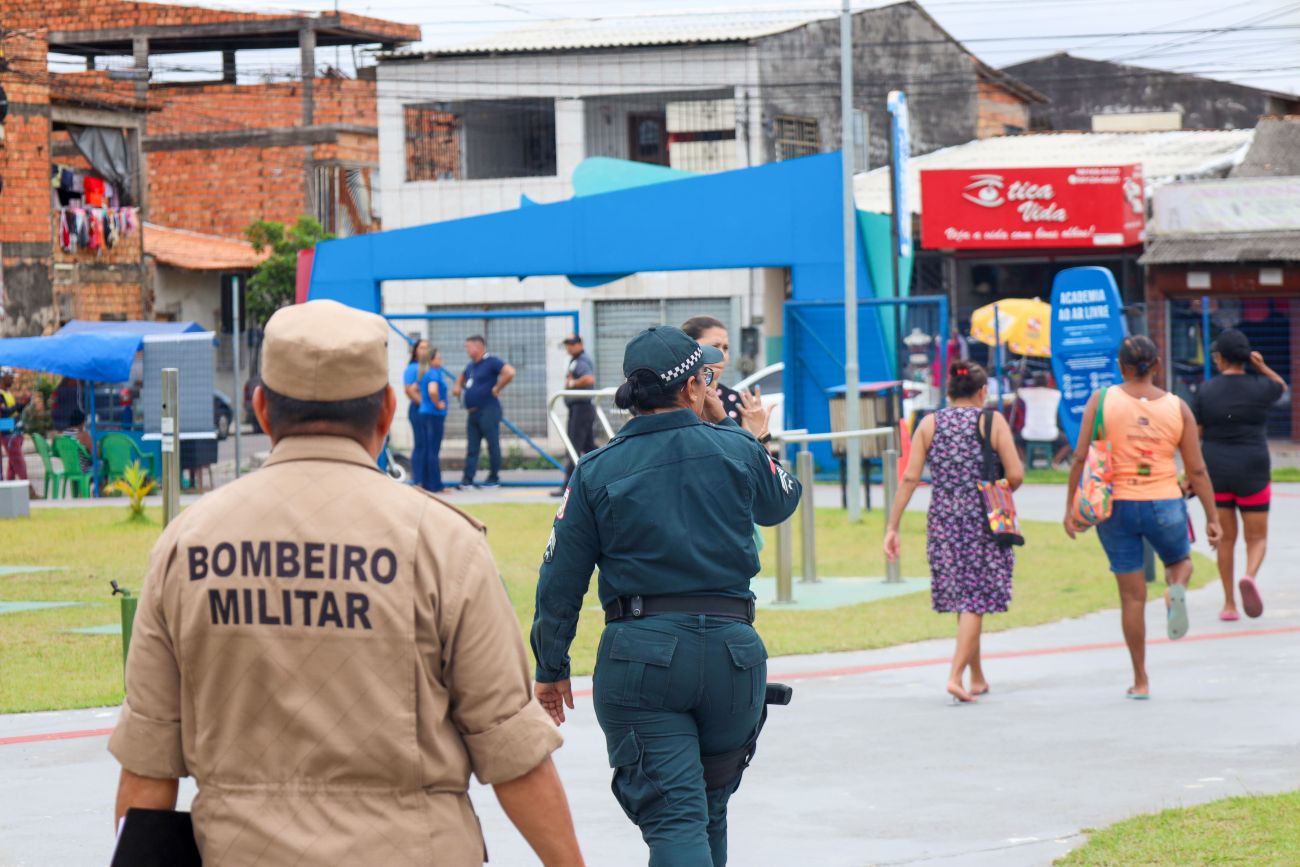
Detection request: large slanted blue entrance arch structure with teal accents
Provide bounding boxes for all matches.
[308,153,906,441]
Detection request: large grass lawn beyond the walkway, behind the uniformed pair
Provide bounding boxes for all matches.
[0,504,1213,712]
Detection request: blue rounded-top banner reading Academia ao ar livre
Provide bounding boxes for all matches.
[1052,265,1128,443]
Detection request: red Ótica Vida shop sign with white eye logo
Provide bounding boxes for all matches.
[920,165,1147,250]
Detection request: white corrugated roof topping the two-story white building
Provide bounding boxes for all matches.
[386,7,873,57]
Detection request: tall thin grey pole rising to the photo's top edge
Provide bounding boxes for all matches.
[840,0,862,524]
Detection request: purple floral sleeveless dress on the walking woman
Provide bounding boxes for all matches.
[926,407,1015,614]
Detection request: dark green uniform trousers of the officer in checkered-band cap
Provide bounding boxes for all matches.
[594,615,767,867]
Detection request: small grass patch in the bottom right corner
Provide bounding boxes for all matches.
[1056,792,1300,867]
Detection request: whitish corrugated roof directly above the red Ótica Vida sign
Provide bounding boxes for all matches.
[853,130,1255,213]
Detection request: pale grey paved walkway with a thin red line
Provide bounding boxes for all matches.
[0,486,1300,867]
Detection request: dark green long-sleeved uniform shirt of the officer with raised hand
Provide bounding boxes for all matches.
[532,409,801,684]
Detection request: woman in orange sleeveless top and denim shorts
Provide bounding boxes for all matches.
[1065,337,1223,699]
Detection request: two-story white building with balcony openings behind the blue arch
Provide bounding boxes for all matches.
[378,1,1041,447]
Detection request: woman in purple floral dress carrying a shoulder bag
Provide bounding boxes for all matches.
[885,361,1024,702]
